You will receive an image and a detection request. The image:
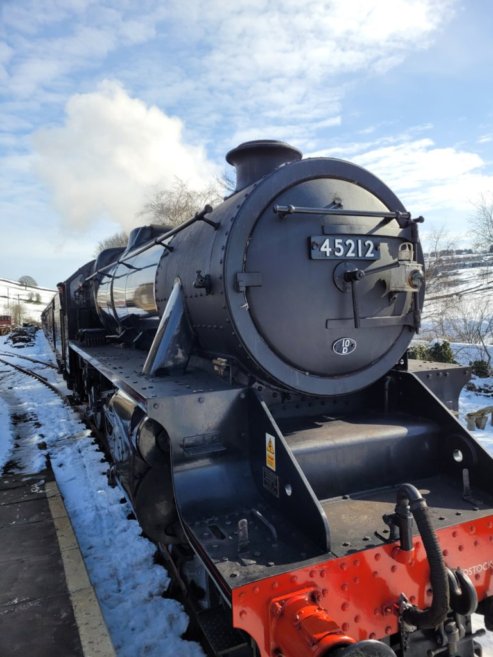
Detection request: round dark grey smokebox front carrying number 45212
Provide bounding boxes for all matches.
[224,158,422,395]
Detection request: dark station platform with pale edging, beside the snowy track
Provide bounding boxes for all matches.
[0,469,115,657]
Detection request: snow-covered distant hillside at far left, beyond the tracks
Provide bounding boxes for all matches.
[0,278,55,323]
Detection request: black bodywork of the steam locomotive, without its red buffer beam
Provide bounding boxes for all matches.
[43,142,493,657]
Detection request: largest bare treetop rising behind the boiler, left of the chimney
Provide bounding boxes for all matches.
[139,178,223,226]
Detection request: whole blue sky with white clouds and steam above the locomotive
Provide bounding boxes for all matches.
[0,0,493,286]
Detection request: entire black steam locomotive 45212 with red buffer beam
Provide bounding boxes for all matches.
[43,141,493,657]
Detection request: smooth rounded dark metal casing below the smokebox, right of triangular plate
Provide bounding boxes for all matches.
[279,411,443,499]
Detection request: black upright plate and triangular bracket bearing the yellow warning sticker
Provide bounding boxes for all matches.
[146,388,329,551]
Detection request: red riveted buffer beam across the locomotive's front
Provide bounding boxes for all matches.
[232,515,493,657]
